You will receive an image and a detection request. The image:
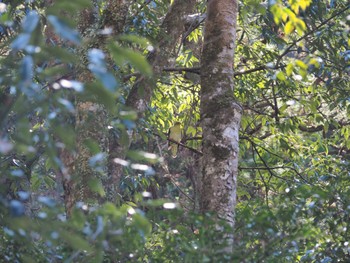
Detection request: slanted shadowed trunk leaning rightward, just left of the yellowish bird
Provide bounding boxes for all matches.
[108,0,196,196]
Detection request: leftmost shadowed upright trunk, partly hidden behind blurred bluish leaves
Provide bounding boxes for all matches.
[58,0,130,215]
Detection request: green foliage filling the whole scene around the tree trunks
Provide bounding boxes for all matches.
[0,0,350,262]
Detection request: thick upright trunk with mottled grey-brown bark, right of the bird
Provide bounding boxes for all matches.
[200,0,242,252]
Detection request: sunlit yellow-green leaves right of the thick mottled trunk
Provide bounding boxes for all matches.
[236,1,348,261]
